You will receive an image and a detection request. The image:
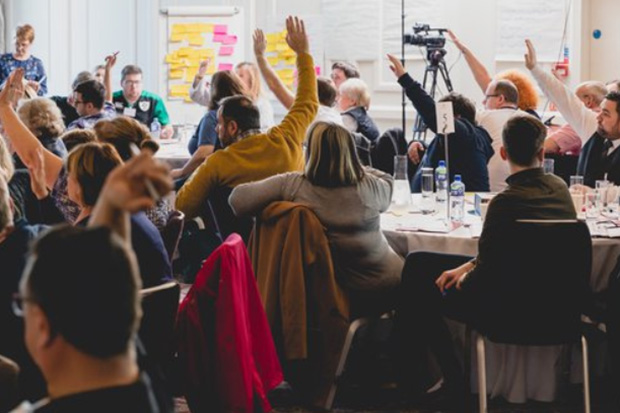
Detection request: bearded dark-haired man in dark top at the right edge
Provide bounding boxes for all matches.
[577,92,620,188]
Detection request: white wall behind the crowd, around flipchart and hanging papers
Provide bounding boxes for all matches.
[4,0,620,129]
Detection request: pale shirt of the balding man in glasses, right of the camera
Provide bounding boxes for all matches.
[476,108,527,192]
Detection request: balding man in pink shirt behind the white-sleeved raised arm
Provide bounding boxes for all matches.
[545,80,607,155]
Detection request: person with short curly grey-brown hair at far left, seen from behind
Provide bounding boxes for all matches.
[14,98,67,168]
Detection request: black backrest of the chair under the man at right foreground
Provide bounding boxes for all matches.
[479,220,592,345]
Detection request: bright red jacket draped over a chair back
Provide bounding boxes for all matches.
[177,234,283,412]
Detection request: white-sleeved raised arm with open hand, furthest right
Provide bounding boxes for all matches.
[525,39,598,143]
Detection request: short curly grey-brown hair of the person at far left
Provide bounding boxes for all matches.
[17,98,65,138]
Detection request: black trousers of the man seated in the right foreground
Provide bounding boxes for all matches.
[394,252,477,392]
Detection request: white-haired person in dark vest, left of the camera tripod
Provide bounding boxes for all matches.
[338,78,379,142]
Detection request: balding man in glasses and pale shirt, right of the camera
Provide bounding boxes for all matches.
[476,80,526,192]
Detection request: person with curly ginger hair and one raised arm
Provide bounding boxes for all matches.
[448,30,540,119]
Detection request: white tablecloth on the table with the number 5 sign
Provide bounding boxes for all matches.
[381,195,620,403]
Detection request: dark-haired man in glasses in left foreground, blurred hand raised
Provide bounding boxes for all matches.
[9,154,172,413]
